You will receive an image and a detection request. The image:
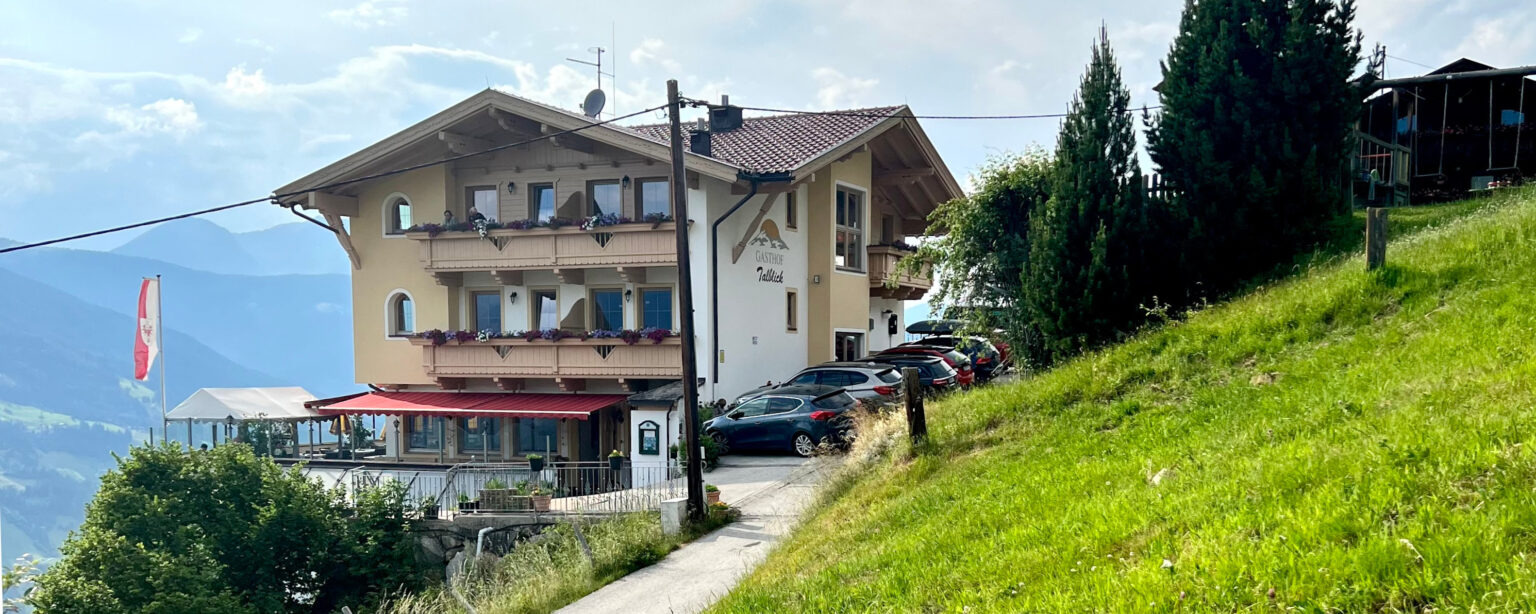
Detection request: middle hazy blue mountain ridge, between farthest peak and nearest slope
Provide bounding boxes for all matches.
[0,247,356,399]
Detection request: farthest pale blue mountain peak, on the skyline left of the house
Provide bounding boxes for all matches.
[112,218,349,275]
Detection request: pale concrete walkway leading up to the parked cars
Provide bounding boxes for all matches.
[556,456,837,614]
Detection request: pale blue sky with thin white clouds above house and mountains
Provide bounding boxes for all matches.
[0,0,1536,249]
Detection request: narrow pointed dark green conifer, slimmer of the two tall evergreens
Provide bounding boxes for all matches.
[1023,29,1146,359]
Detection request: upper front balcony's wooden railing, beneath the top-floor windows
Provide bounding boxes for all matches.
[406,221,677,273]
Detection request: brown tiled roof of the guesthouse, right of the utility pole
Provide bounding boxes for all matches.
[628,106,902,172]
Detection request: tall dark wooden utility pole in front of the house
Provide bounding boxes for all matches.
[667,78,703,520]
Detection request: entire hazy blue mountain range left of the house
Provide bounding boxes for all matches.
[0,220,358,560]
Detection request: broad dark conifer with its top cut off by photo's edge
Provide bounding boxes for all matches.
[1147,0,1361,293]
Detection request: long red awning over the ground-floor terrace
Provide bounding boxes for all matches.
[316,391,625,421]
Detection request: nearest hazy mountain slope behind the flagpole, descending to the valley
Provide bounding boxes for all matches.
[0,268,284,560]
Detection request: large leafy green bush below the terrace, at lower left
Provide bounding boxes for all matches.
[31,444,427,612]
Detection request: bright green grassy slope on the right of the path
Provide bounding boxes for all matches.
[714,192,1536,612]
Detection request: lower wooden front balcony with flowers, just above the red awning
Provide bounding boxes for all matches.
[410,336,682,390]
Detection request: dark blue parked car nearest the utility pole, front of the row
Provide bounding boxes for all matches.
[703,384,857,456]
